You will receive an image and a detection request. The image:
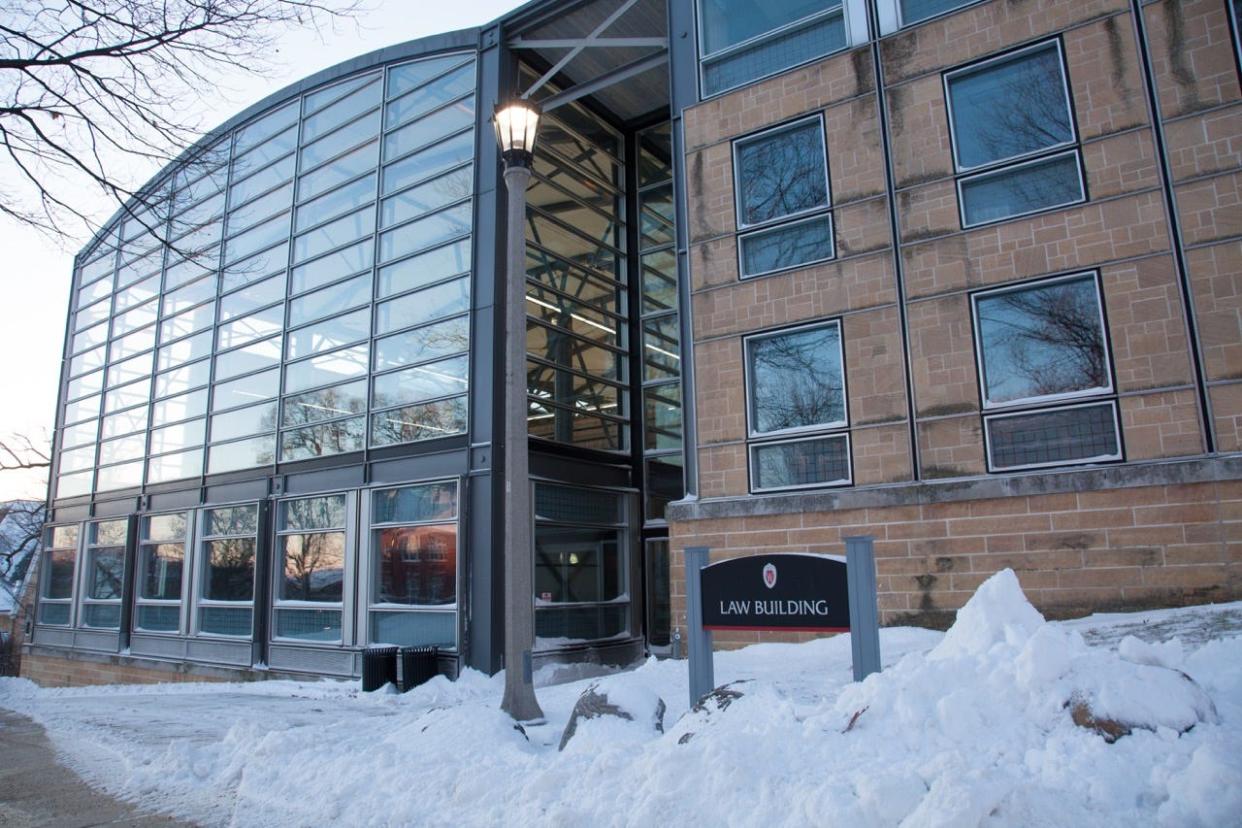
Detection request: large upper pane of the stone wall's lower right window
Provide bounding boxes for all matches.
[976,276,1112,403]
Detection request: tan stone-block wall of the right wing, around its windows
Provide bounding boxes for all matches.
[671,0,1242,644]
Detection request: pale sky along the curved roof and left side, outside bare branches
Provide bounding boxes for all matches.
[0,0,520,500]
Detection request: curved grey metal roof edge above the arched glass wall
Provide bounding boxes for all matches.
[71,24,479,265]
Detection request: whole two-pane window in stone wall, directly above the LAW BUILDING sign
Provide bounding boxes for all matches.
[745,322,851,492]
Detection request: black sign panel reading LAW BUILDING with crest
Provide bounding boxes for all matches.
[702,554,850,632]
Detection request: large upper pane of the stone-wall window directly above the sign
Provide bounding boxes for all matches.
[746,323,846,433]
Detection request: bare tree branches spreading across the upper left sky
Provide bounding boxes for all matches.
[0,0,360,241]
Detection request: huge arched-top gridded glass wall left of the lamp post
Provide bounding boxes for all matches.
[56,53,476,506]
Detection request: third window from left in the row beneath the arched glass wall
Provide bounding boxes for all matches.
[134,513,189,633]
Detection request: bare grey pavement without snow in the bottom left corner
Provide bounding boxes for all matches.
[0,710,189,828]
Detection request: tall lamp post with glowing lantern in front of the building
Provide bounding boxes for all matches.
[493,99,544,721]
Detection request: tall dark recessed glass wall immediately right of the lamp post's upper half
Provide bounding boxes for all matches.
[523,64,630,452]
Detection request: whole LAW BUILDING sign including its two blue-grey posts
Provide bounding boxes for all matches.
[686,535,879,708]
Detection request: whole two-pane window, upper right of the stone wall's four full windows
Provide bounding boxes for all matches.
[945,40,1087,227]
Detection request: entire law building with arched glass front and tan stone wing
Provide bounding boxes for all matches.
[24,0,1242,682]
